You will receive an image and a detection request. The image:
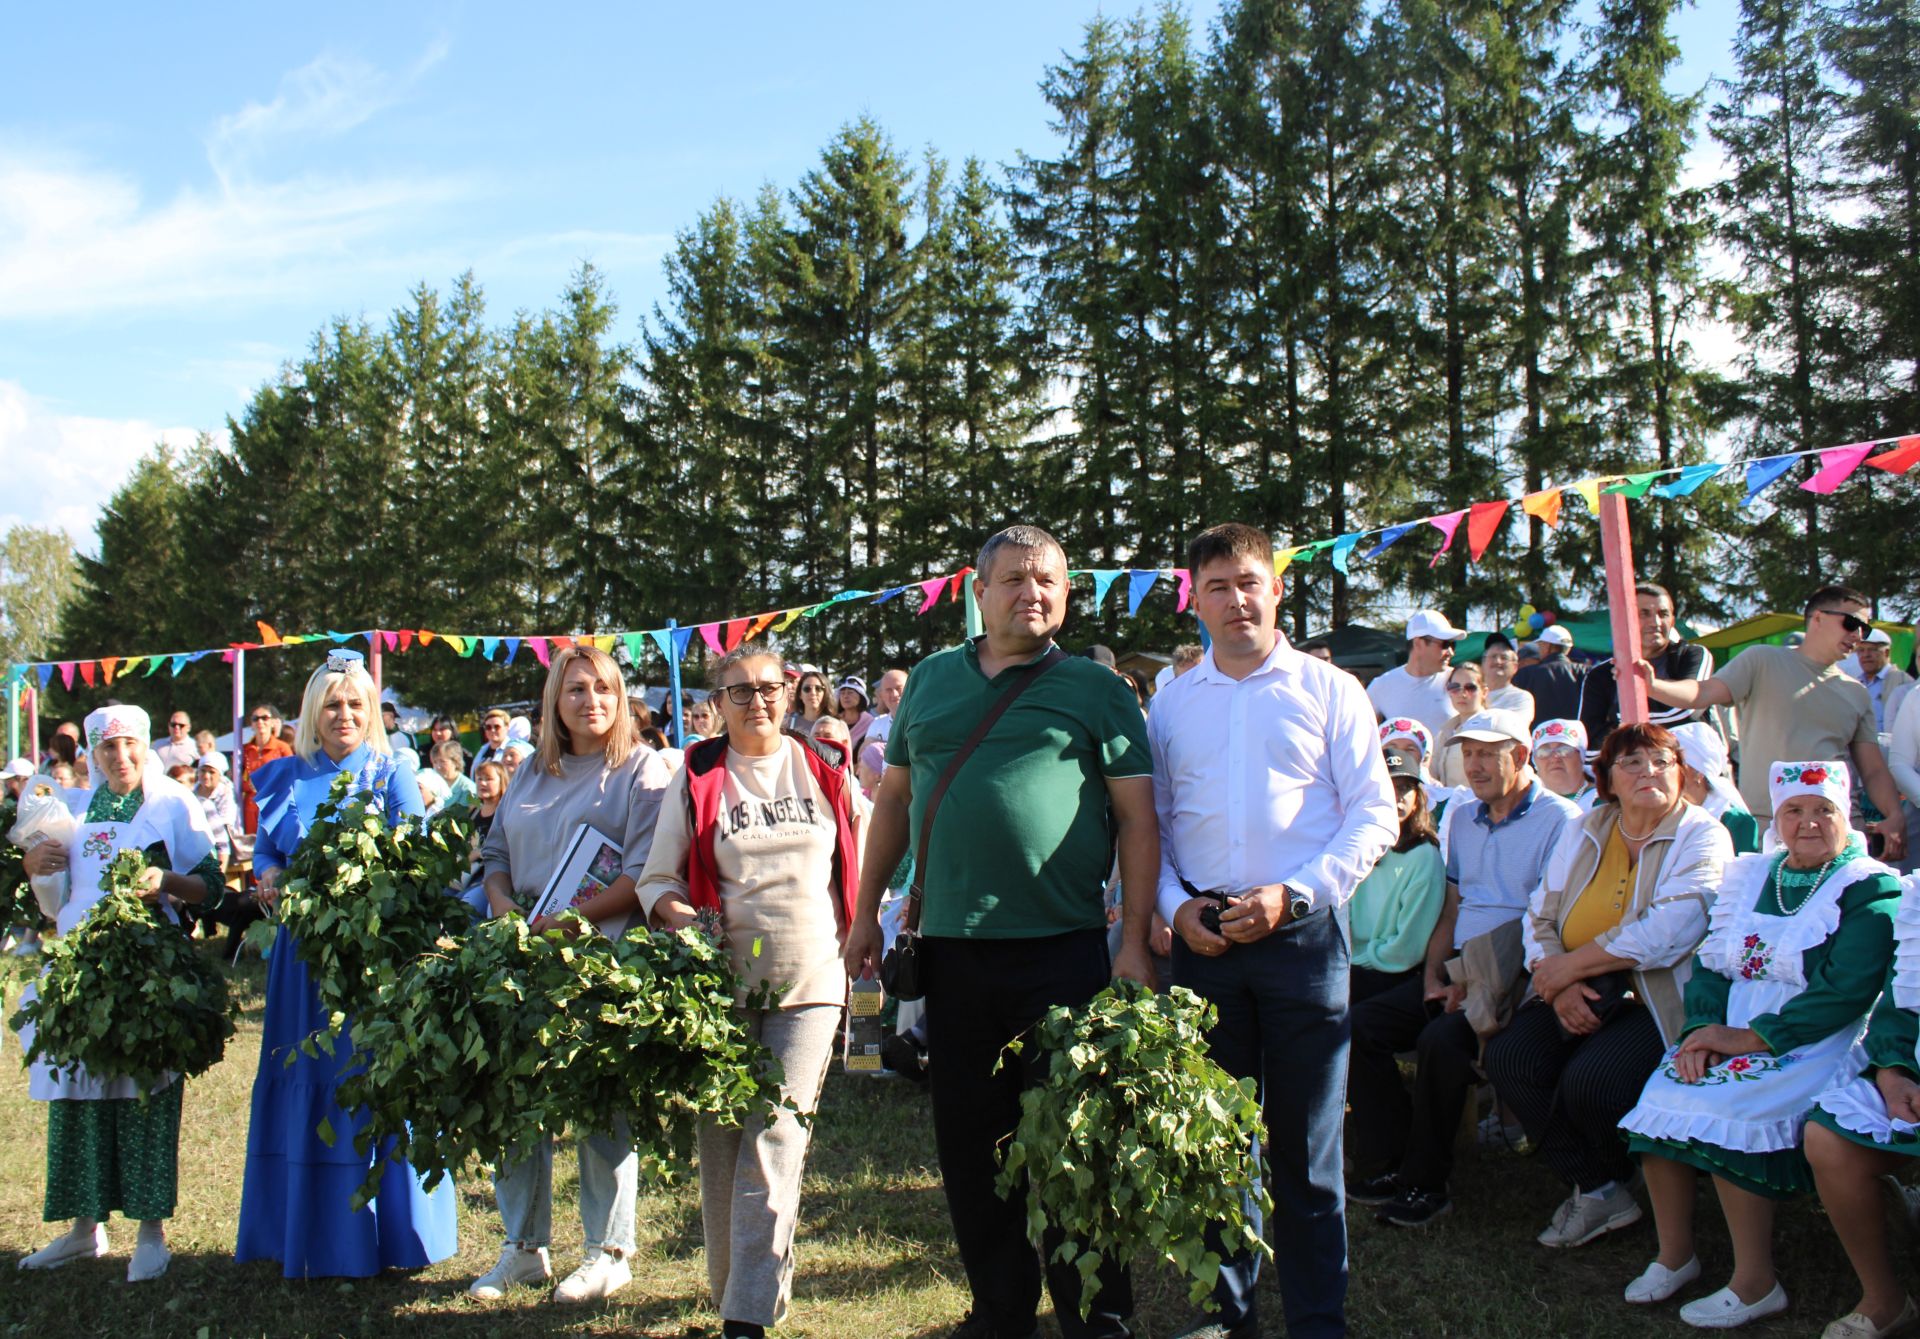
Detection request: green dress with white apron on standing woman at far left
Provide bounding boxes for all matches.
[21,776,227,1222]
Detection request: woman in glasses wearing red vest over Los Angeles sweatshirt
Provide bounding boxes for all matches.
[639,645,860,1339]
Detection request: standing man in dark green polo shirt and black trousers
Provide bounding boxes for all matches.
[847,526,1160,1339]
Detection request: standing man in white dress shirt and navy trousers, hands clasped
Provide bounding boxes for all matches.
[1146,524,1398,1339]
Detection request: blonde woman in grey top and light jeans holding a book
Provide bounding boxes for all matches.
[468,645,670,1302]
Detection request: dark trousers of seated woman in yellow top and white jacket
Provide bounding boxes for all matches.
[1486,999,1667,1191]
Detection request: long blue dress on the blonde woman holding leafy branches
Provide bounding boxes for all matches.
[234,745,459,1279]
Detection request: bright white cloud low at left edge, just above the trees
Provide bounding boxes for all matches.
[0,380,212,551]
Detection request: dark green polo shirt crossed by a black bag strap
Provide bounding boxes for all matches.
[887,642,1154,939]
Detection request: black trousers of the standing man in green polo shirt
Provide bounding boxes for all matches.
[920,928,1133,1339]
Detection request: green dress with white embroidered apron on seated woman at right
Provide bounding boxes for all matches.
[1620,838,1899,1199]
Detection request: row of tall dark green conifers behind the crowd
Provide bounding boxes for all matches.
[33,0,1920,717]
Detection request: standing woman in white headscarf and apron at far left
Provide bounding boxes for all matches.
[19,705,227,1283]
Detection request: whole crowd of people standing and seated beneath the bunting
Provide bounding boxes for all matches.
[10,524,1920,1339]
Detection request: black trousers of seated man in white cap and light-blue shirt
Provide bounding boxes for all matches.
[1346,972,1480,1191]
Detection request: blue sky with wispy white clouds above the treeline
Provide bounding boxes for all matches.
[0,0,1736,546]
